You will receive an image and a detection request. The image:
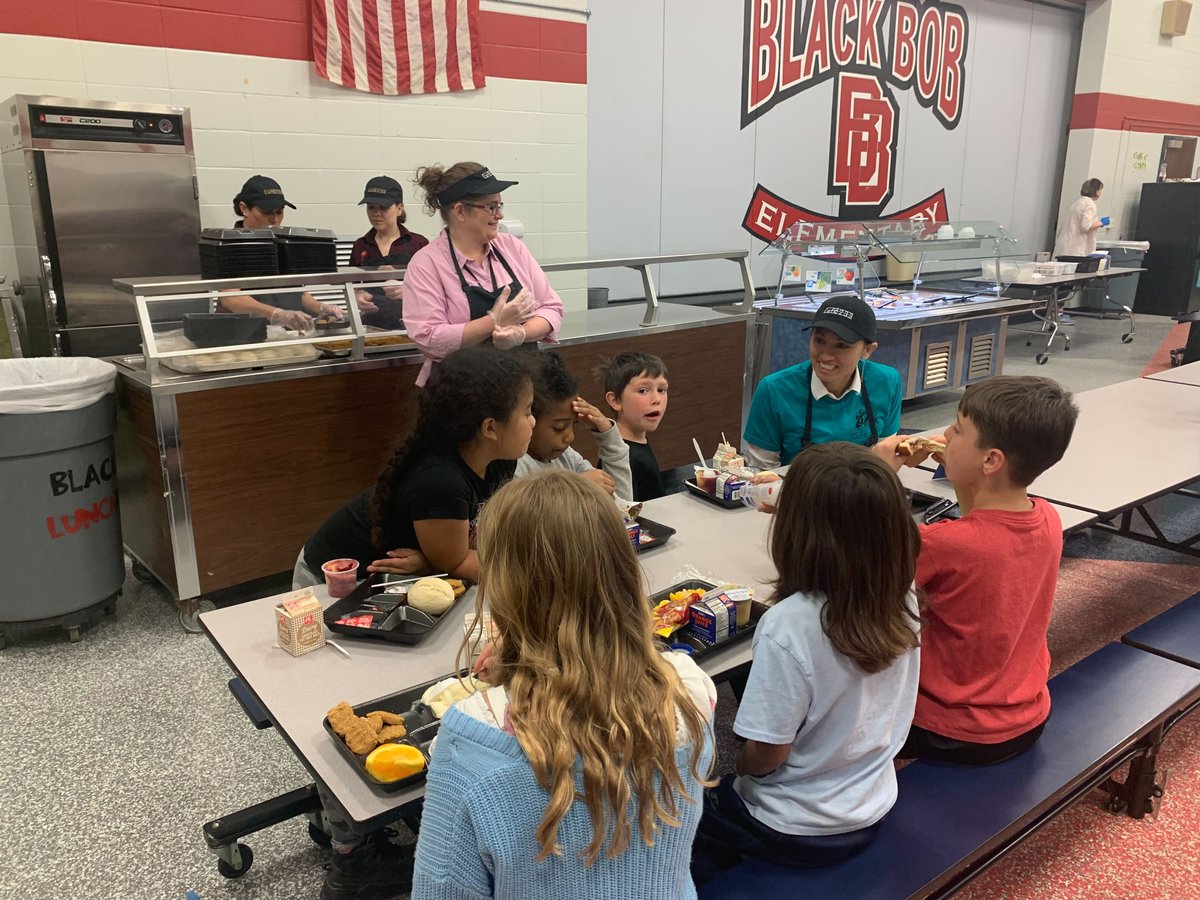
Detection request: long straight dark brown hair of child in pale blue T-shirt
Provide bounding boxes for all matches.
[770,442,920,673]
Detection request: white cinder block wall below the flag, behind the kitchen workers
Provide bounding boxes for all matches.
[0,2,588,308]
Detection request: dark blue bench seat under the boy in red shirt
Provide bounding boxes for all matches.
[700,643,1200,900]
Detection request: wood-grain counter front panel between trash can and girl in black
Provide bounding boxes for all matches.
[176,366,418,593]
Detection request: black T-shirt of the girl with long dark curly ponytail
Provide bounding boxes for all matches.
[304,454,514,575]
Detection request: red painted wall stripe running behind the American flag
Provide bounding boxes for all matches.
[0,0,588,84]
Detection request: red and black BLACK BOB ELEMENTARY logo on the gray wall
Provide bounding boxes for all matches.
[739,0,968,240]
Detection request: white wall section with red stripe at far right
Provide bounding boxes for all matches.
[1058,0,1200,238]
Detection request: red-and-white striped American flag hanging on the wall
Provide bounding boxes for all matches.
[312,0,485,94]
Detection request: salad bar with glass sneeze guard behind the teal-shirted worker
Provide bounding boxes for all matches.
[752,220,1040,400]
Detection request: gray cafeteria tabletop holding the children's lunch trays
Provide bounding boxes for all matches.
[200,494,773,849]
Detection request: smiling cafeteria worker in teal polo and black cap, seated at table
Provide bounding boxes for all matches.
[742,296,904,469]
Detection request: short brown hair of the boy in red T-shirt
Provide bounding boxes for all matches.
[959,376,1079,487]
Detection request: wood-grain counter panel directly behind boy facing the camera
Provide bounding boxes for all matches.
[558,322,746,469]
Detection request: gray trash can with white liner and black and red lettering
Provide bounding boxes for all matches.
[0,359,125,646]
